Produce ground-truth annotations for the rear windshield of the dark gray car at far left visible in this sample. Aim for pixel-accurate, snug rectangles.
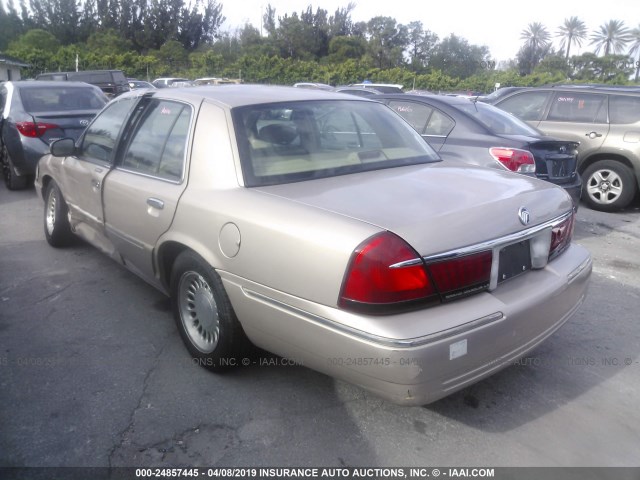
[20,86,107,112]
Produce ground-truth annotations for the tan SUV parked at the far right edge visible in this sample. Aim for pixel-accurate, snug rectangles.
[494,85,640,211]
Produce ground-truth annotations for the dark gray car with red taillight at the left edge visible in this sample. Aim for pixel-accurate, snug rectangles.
[0,81,107,190]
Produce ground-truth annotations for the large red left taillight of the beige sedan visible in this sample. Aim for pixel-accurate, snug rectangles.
[339,232,492,314]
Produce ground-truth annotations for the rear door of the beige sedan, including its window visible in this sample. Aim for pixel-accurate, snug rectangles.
[104,98,194,283]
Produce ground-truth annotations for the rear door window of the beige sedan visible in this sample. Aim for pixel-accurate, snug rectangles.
[121,100,191,181]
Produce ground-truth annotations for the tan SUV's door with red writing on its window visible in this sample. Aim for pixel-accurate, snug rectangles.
[538,91,609,158]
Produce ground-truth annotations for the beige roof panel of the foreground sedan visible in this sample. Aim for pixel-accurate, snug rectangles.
[130,85,369,108]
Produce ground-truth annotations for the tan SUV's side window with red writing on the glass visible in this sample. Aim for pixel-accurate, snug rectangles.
[547,92,607,123]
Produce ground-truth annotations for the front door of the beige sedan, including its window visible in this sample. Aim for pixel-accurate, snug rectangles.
[57,94,135,254]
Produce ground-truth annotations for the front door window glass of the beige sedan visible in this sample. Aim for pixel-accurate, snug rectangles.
[79,98,134,163]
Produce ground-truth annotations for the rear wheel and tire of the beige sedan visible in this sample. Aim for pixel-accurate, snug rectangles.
[171,251,248,371]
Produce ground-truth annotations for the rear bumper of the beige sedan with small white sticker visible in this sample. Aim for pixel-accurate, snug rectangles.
[220,244,592,405]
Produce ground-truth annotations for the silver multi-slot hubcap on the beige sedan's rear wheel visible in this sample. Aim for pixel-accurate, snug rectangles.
[178,272,220,353]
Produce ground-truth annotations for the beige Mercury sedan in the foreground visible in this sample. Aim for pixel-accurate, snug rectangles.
[36,85,591,405]
